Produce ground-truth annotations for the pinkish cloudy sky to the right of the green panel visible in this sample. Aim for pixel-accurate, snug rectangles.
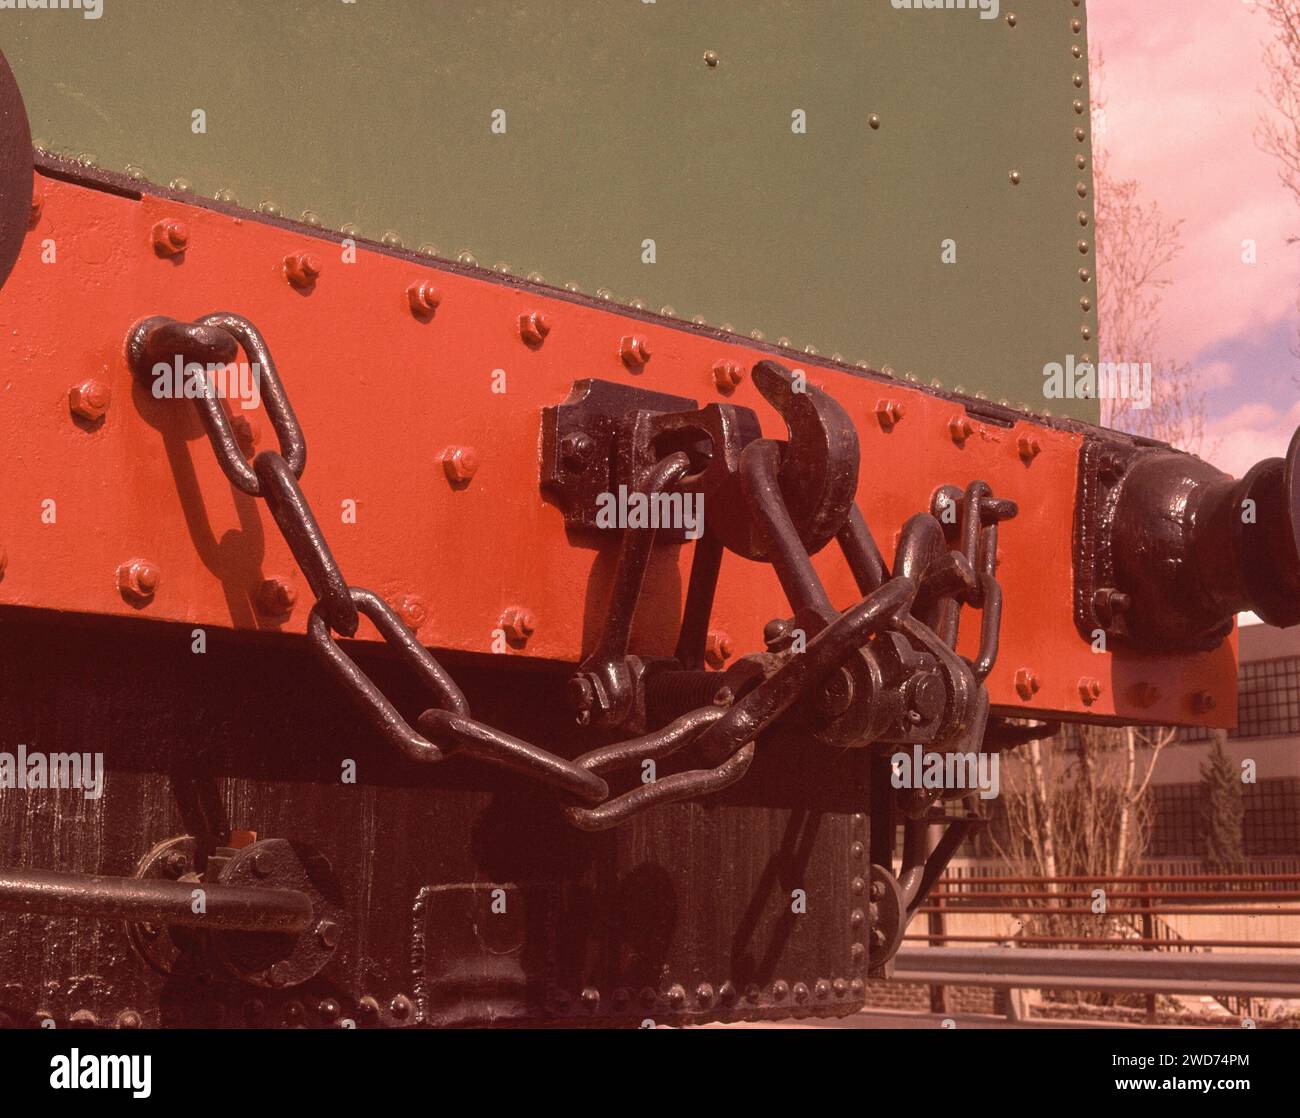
[1088,0,1300,475]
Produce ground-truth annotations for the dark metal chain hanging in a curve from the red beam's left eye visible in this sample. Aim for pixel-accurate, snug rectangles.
[129,312,761,831]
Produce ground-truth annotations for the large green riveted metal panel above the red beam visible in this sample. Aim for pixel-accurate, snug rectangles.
[0,0,1096,420]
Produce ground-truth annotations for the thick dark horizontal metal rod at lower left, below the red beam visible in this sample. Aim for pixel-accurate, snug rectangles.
[0,870,312,935]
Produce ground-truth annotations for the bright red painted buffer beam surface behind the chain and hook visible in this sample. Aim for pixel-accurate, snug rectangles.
[0,165,1236,724]
